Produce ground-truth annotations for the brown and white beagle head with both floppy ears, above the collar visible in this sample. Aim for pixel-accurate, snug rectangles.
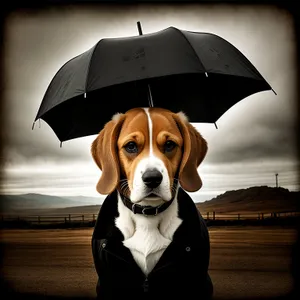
[91,108,207,203]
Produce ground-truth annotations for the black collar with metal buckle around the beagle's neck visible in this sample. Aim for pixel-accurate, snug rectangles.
[120,194,174,216]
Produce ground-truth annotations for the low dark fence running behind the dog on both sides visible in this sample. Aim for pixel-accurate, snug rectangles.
[0,211,300,225]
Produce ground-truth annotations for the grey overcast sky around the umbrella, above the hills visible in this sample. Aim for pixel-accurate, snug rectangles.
[0,4,299,200]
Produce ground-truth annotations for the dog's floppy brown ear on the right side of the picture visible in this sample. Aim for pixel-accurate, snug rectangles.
[174,112,207,192]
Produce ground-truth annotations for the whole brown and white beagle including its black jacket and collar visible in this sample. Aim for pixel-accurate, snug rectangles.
[91,107,213,299]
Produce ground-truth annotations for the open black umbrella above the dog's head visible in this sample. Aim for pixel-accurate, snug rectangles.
[35,22,272,142]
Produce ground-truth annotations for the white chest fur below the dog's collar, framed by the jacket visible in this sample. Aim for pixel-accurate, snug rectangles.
[115,198,182,275]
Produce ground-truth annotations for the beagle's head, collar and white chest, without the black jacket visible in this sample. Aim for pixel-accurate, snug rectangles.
[91,107,207,276]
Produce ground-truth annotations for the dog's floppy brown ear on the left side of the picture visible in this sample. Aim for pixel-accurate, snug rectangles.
[91,114,125,195]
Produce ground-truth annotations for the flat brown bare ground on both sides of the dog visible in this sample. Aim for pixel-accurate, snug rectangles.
[1,227,296,299]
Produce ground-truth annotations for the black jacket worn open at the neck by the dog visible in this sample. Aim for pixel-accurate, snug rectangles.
[92,189,213,300]
